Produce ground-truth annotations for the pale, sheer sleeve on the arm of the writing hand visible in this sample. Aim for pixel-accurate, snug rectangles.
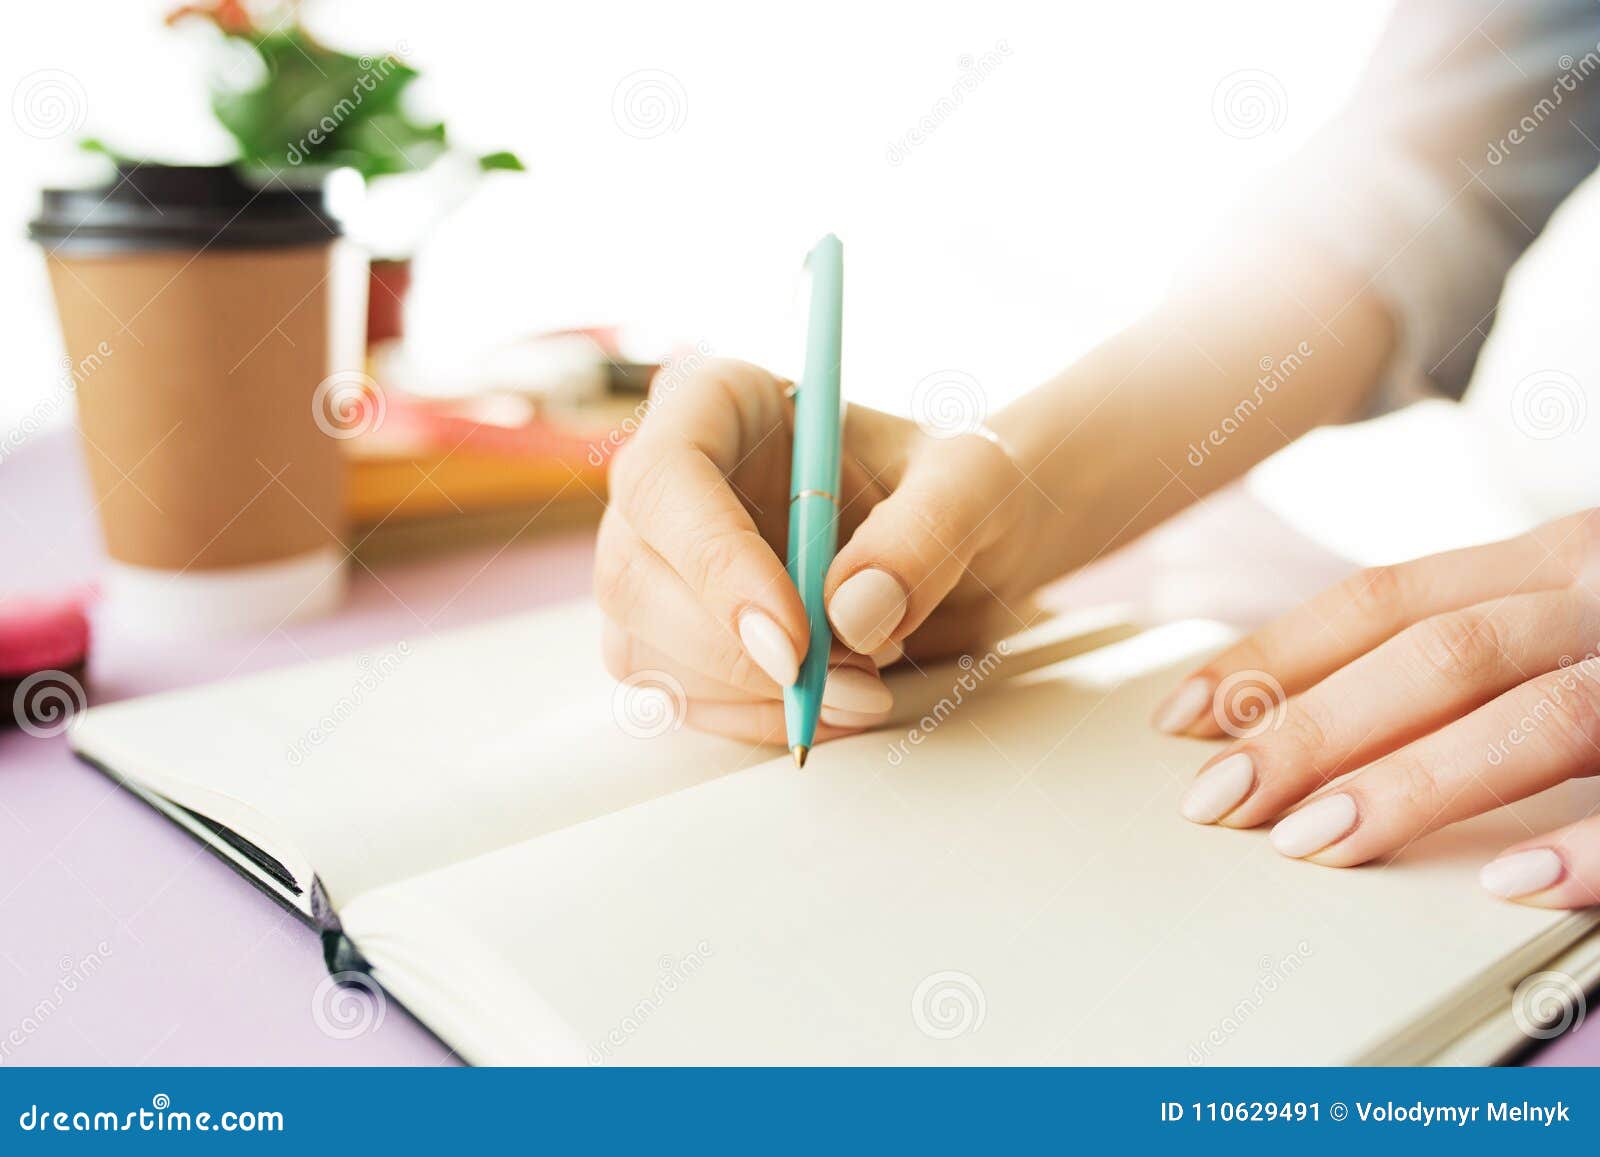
[1209,0,1600,408]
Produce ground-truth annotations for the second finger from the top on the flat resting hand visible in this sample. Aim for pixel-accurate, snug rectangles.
[1181,587,1600,827]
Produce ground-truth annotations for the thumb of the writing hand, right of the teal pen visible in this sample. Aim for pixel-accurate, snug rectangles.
[824,434,1022,653]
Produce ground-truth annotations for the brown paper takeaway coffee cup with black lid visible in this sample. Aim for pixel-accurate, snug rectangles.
[29,165,358,631]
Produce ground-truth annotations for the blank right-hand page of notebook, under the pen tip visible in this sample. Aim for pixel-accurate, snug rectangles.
[342,624,1597,1064]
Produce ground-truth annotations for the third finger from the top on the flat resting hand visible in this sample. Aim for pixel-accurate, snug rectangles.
[1270,658,1600,867]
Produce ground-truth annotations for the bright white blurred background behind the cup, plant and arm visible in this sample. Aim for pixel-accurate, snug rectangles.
[0,0,1600,560]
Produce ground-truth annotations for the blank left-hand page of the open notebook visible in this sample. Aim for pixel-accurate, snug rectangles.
[72,603,765,904]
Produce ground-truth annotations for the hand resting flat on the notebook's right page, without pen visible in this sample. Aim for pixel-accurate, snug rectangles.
[1155,510,1600,907]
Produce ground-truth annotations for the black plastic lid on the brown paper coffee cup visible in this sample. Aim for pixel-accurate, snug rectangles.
[27,163,339,253]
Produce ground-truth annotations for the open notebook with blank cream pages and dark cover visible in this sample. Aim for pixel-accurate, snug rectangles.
[72,607,1600,1064]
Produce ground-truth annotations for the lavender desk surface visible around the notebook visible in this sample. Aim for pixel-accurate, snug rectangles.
[0,434,1600,1064]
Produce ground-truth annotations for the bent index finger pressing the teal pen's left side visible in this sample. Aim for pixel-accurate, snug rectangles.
[610,362,808,685]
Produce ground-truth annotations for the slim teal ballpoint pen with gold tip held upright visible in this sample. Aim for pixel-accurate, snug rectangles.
[784,234,845,767]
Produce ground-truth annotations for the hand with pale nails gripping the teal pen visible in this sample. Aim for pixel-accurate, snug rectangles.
[595,362,1037,743]
